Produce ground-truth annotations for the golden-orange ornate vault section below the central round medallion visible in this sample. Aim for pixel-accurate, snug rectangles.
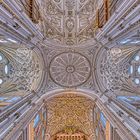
[46,93,94,136]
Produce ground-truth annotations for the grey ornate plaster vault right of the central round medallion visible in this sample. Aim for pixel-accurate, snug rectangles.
[95,46,139,95]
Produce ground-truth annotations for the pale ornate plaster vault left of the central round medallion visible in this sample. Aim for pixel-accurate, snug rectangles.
[0,38,43,96]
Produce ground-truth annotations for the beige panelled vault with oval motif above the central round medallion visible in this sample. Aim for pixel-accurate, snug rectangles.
[43,0,95,45]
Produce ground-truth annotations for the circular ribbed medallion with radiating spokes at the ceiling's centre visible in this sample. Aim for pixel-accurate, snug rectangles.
[50,52,90,87]
